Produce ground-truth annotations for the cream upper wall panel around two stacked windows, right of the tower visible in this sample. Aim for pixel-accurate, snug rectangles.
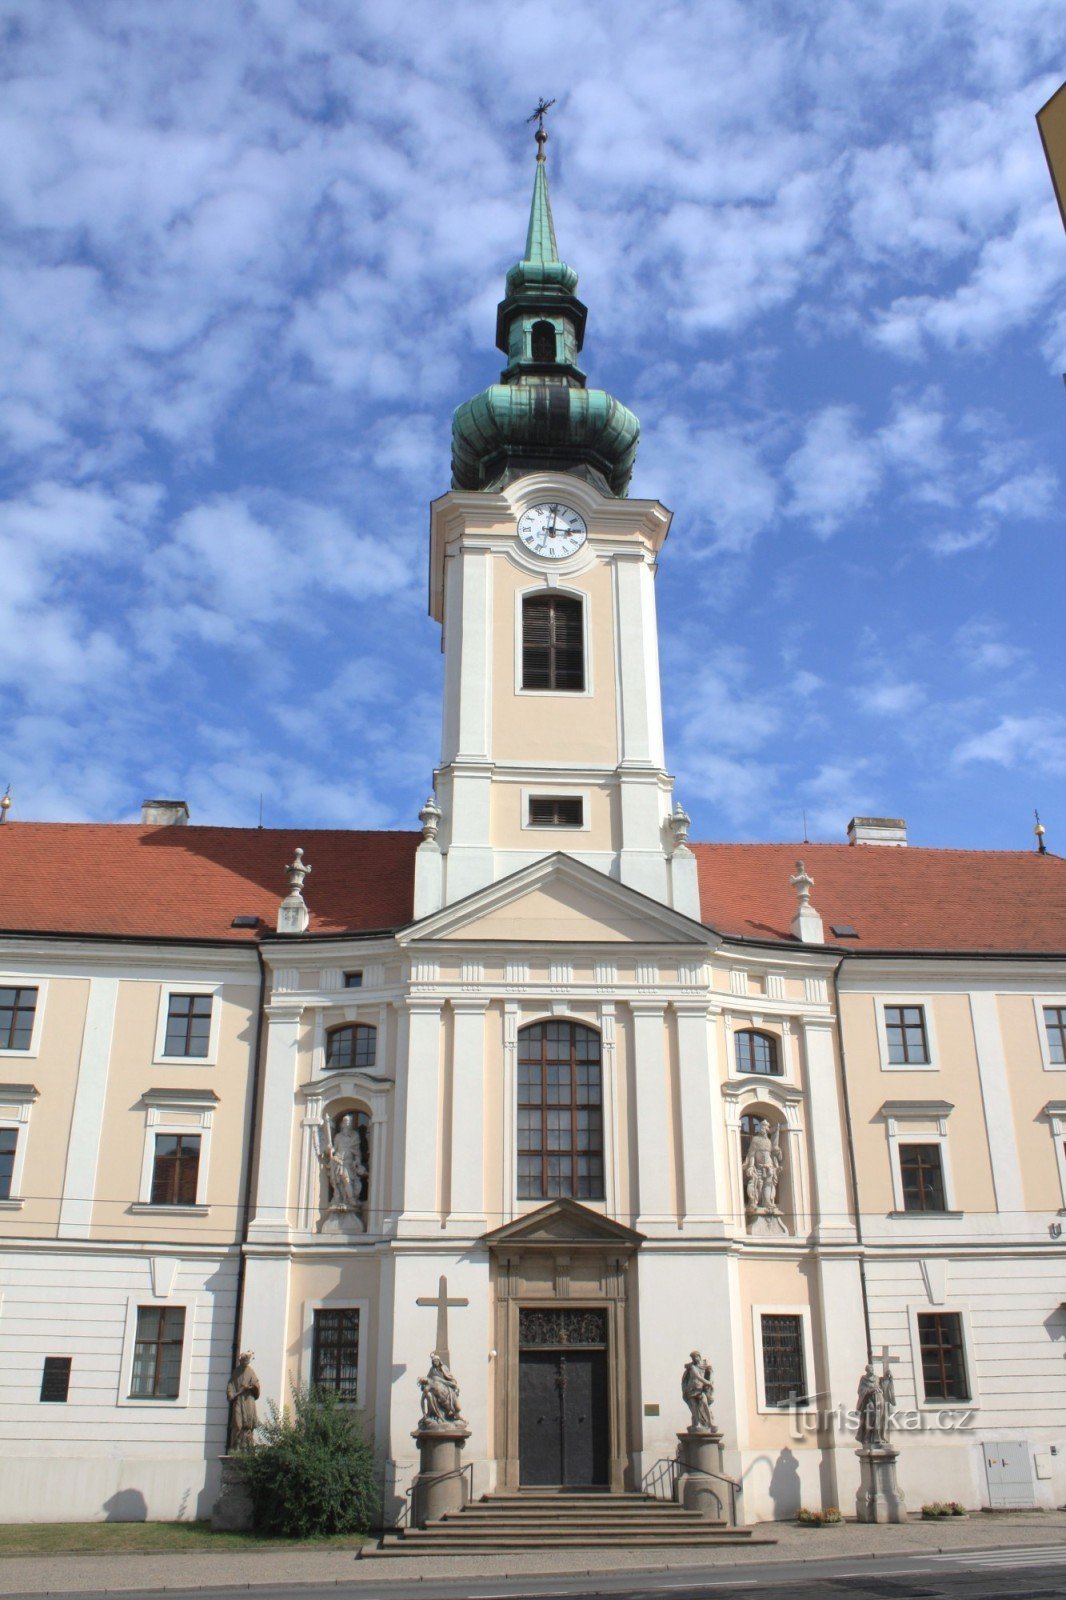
[840,990,996,1213]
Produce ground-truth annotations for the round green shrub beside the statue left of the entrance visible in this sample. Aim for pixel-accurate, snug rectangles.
[235,1384,379,1539]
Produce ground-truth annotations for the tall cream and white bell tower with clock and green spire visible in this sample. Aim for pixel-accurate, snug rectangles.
[408,117,699,936]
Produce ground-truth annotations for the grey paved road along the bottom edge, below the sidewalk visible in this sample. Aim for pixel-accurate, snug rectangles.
[14,1544,1066,1600]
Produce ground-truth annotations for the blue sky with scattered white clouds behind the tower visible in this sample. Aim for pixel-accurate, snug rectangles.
[0,0,1066,848]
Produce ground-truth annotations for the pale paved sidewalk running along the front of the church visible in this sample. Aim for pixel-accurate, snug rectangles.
[0,1510,1066,1595]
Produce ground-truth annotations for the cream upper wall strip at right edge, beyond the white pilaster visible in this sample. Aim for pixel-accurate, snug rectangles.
[997,995,1066,1213]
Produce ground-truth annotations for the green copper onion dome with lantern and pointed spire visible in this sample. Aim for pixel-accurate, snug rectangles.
[451,133,640,496]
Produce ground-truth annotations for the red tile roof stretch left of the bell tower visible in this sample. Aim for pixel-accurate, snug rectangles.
[0,822,421,944]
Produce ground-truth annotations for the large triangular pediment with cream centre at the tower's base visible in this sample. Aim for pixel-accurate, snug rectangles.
[400,854,707,946]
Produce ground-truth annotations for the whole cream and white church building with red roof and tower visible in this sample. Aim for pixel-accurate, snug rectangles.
[0,142,1066,1522]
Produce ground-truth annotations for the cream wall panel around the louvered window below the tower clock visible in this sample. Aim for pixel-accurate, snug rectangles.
[491,557,618,766]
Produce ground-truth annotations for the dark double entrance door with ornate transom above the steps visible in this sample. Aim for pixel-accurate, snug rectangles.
[519,1310,610,1488]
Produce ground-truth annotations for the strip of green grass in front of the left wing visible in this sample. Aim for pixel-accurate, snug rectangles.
[0,1522,365,1555]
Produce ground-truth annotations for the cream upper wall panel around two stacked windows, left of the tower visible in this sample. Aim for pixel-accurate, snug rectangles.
[93,981,258,1245]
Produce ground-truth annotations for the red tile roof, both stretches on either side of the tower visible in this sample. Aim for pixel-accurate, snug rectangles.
[0,822,1066,954]
